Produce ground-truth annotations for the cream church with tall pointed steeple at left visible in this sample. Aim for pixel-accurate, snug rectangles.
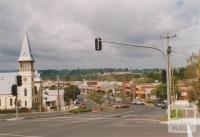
[0,34,43,109]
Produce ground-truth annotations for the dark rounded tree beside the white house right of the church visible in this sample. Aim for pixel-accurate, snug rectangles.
[64,85,81,103]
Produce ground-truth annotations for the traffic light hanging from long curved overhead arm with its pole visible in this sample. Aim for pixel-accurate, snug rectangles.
[95,36,171,120]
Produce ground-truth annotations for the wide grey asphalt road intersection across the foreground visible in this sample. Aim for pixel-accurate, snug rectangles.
[0,106,200,137]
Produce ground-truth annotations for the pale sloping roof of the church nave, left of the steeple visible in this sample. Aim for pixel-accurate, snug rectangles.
[0,72,18,95]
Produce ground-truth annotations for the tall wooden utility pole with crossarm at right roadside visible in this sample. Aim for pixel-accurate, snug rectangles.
[160,32,176,120]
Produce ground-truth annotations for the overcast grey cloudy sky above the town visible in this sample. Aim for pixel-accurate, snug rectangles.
[0,0,200,70]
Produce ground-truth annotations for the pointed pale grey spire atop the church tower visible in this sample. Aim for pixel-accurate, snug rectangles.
[18,33,34,61]
